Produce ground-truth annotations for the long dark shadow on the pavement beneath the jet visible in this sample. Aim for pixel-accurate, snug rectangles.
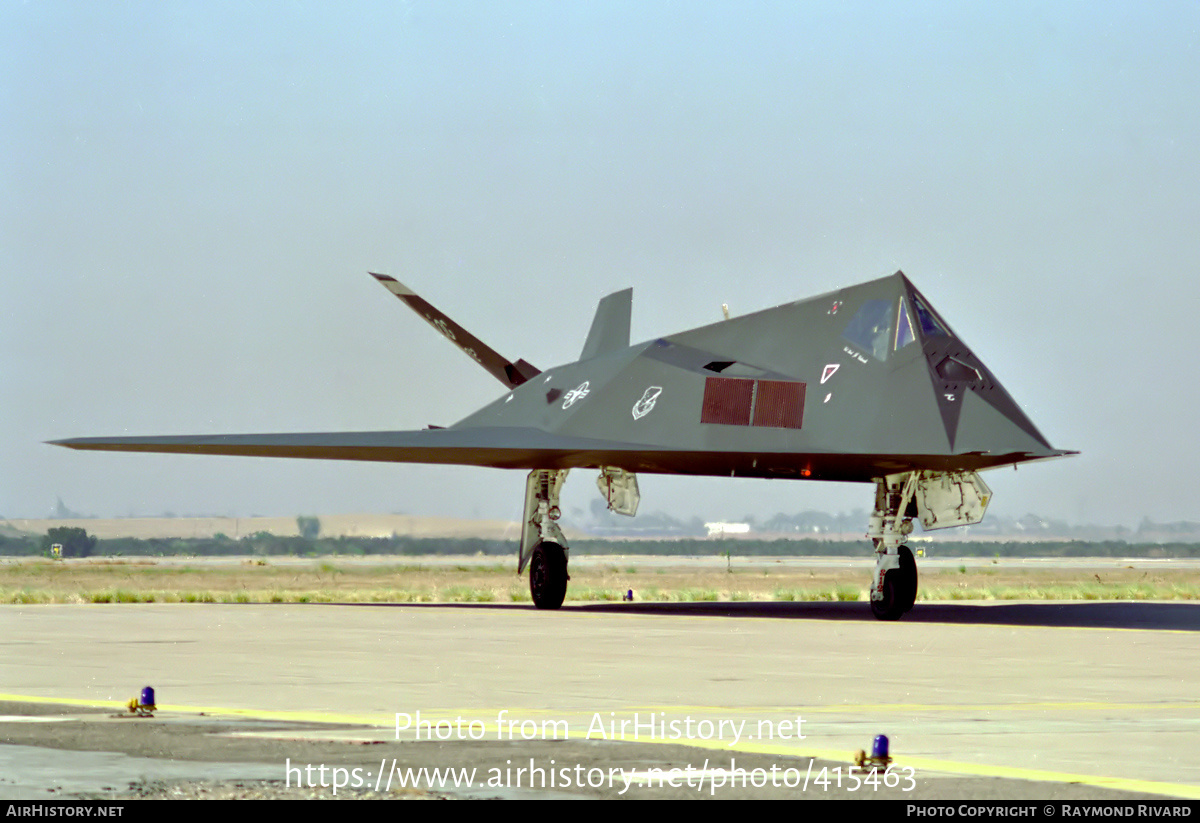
[340,601,1200,631]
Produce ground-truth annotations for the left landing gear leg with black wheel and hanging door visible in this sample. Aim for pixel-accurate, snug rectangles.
[517,465,641,608]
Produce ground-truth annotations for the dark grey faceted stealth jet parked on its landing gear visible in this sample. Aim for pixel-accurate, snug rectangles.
[54,271,1075,620]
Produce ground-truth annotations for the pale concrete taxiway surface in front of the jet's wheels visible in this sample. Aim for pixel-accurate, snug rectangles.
[0,602,1200,799]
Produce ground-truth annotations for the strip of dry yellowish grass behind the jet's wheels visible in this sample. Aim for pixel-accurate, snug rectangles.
[0,558,1200,603]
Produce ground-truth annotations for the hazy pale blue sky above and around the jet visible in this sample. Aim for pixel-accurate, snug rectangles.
[0,0,1200,524]
